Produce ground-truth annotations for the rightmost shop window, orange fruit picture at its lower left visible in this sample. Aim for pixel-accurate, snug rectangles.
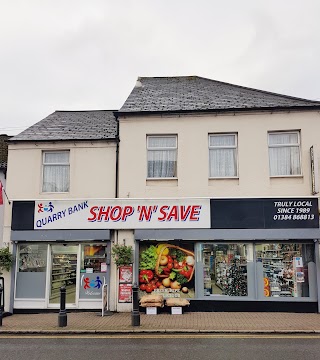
[256,243,314,297]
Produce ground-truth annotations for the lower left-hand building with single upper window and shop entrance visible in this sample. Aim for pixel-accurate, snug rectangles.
[4,111,118,311]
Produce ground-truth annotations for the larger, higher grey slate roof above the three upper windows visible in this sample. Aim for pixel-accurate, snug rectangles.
[119,76,320,114]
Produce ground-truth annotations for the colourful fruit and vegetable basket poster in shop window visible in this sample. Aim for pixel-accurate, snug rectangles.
[139,242,195,298]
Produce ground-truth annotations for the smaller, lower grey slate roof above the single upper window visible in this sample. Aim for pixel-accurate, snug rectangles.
[10,110,117,141]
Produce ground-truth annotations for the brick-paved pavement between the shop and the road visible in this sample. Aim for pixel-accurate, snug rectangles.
[0,312,320,335]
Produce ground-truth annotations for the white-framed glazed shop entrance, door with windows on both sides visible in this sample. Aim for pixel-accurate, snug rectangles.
[15,242,110,307]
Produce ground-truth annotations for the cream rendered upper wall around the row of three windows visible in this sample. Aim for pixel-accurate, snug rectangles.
[119,111,320,198]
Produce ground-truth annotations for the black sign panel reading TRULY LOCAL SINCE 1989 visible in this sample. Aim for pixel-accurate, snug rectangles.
[210,198,319,229]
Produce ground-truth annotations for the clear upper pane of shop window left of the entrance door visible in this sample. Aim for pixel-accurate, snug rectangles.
[18,244,47,272]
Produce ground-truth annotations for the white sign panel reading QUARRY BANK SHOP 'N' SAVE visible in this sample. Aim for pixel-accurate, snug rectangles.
[34,198,210,230]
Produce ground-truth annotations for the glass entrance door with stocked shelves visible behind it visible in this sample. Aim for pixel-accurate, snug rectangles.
[49,245,78,304]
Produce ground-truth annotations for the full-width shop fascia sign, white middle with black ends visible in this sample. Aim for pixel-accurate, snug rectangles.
[11,197,319,230]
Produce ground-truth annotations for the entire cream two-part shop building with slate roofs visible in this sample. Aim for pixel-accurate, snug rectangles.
[5,77,320,312]
